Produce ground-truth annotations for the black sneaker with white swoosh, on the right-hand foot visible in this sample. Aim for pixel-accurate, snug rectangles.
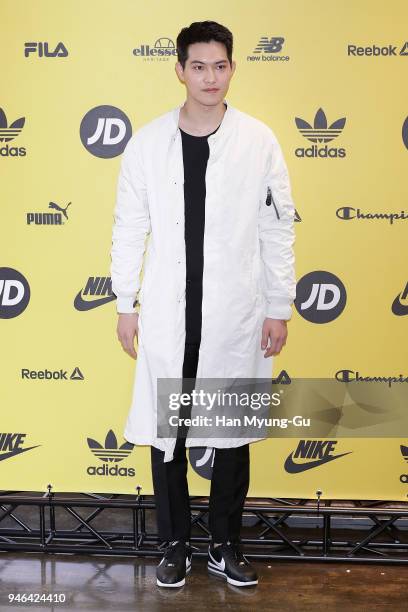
[208,542,258,586]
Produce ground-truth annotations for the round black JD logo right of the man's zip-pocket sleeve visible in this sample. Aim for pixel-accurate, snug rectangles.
[295,270,347,323]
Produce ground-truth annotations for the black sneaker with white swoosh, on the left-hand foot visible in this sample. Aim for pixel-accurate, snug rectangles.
[156,540,191,587]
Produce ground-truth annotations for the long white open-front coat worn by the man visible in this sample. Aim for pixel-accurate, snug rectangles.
[111,101,296,461]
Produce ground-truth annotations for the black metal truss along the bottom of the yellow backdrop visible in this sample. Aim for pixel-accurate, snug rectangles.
[0,485,408,564]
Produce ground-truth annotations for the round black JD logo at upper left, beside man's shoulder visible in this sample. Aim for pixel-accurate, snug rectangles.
[79,106,132,159]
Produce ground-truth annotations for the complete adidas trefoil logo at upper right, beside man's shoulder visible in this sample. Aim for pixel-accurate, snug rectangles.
[295,108,346,158]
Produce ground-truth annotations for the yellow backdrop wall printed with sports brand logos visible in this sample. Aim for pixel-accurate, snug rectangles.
[0,0,408,499]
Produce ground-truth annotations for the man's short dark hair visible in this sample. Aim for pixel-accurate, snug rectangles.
[176,21,233,69]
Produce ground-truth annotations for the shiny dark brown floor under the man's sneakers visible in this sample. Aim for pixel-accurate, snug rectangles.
[0,552,408,612]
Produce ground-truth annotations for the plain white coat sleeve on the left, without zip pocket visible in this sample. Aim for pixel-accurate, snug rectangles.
[110,135,151,313]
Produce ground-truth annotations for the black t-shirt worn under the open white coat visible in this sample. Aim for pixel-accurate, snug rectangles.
[180,126,219,343]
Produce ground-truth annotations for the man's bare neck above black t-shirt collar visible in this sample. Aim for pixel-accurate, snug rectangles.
[179,98,226,136]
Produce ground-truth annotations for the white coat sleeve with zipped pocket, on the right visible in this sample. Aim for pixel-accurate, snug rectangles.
[258,130,296,321]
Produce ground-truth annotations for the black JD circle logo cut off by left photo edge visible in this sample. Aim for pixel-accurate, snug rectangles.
[0,268,30,319]
